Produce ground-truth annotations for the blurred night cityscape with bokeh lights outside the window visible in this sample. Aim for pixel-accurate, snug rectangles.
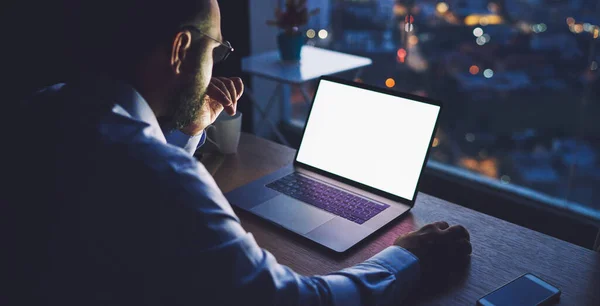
[292,0,600,218]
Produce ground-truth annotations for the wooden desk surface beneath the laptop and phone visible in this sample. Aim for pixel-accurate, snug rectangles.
[205,134,600,306]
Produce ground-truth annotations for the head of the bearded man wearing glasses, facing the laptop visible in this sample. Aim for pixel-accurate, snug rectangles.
[70,0,227,127]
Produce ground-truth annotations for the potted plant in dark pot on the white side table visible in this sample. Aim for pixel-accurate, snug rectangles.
[267,0,319,61]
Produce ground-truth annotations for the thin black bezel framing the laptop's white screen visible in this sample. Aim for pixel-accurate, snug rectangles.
[294,76,443,207]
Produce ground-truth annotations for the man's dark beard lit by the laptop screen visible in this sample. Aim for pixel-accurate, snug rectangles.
[169,74,206,129]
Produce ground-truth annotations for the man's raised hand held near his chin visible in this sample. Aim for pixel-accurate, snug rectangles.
[181,77,244,136]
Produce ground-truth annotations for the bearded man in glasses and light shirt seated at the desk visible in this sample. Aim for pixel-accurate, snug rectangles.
[3,0,471,306]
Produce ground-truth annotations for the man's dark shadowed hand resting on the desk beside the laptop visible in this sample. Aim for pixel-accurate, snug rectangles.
[394,221,472,280]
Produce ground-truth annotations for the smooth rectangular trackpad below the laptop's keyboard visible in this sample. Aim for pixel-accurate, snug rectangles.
[250,195,335,234]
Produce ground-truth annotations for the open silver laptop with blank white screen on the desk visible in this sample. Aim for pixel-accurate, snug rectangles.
[225,76,441,252]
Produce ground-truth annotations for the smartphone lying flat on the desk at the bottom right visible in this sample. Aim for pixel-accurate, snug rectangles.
[477,273,560,306]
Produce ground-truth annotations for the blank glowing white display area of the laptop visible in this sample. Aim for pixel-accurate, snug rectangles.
[297,80,440,200]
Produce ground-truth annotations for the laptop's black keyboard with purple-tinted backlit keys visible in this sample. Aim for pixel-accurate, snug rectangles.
[267,173,390,224]
